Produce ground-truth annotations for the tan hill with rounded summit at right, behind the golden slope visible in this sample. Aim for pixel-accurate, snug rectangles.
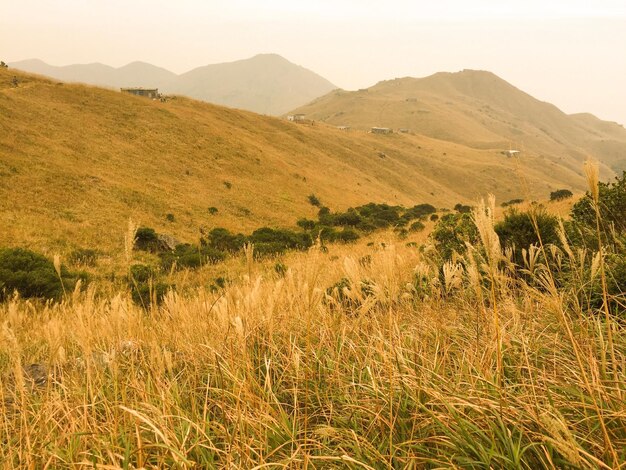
[294,70,626,177]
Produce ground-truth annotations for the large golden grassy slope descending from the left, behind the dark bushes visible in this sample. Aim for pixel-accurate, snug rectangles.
[0,69,585,251]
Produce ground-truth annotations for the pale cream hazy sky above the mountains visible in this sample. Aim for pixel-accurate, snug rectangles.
[0,0,626,124]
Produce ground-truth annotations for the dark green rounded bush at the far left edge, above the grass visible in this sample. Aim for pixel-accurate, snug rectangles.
[0,248,78,300]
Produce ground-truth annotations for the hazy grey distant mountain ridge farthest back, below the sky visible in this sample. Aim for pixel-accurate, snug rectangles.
[9,54,336,115]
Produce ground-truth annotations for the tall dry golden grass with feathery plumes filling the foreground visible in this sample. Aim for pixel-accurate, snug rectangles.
[0,218,626,469]
